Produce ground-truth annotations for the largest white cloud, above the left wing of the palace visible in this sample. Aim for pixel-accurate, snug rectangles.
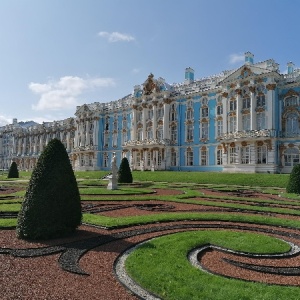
[28,76,115,111]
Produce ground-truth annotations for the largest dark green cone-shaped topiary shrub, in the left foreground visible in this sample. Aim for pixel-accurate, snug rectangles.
[17,139,82,239]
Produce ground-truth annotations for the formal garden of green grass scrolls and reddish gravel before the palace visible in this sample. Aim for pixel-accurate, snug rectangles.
[0,146,300,300]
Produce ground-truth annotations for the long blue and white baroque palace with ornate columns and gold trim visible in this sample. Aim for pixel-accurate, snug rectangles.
[0,52,300,173]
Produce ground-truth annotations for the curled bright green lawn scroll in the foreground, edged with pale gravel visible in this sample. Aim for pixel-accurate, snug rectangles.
[126,230,299,300]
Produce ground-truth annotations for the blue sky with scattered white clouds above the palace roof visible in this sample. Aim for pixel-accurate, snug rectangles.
[0,0,300,126]
